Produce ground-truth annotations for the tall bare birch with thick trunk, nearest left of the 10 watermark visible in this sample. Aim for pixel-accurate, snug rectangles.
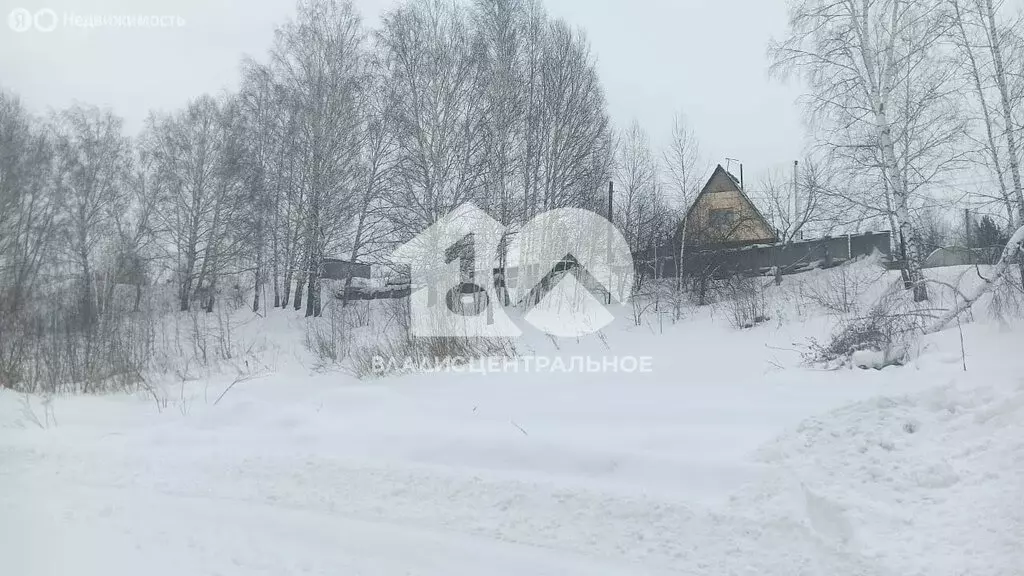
[271,0,367,317]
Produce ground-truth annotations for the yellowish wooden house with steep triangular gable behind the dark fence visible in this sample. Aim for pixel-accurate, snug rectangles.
[685,164,778,252]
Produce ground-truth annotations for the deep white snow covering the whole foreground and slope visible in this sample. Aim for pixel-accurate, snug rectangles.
[0,262,1024,576]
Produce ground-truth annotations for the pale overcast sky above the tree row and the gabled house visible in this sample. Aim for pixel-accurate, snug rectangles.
[0,0,803,181]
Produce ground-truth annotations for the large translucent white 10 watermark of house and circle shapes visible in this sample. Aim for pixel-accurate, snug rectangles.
[391,203,634,337]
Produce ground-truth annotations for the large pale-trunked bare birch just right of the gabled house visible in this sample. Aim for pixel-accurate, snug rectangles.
[769,0,951,300]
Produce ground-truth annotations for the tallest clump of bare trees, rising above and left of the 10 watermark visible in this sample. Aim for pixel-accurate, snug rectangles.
[235,0,611,316]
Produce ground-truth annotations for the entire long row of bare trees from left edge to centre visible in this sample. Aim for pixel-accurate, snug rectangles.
[0,0,613,386]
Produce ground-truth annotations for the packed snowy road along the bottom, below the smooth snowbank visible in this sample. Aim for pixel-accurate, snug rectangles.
[3,428,876,574]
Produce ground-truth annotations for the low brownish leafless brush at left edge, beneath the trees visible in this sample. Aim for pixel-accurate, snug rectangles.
[0,276,276,394]
